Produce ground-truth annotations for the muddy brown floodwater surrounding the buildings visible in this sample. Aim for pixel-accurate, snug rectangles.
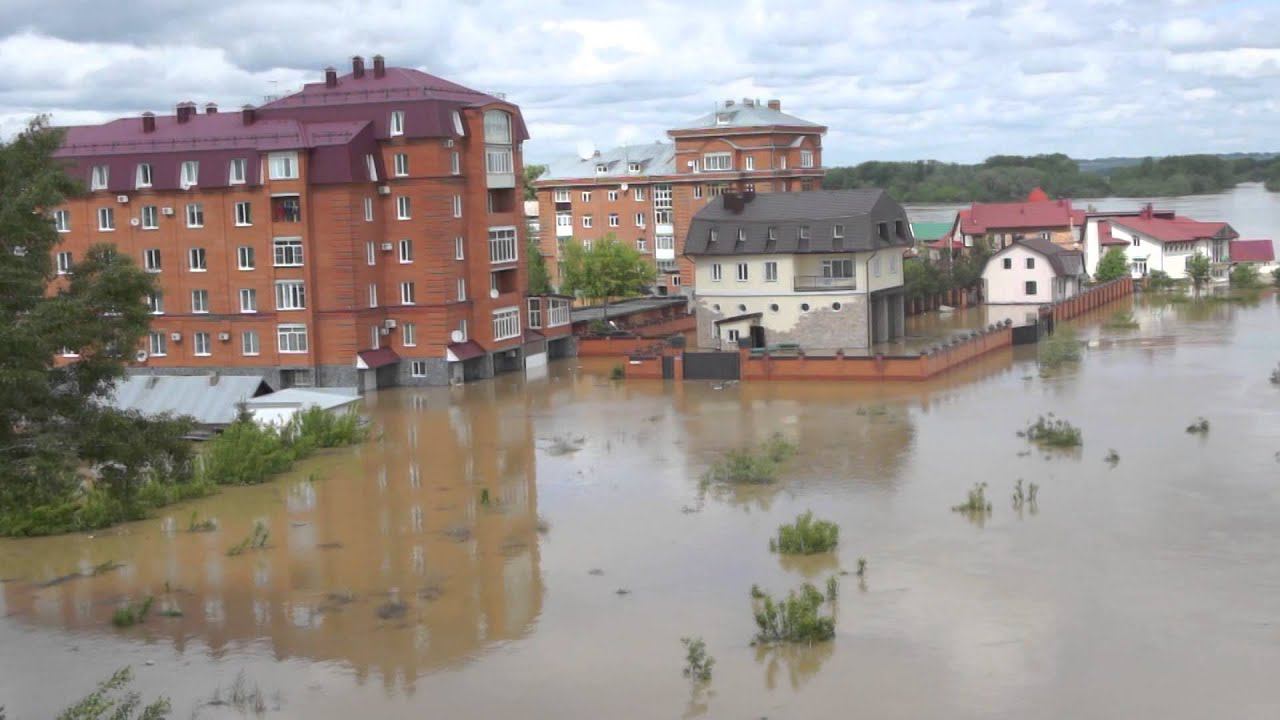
[0,288,1280,720]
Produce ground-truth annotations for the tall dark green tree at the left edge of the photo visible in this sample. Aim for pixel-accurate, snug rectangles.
[0,118,191,534]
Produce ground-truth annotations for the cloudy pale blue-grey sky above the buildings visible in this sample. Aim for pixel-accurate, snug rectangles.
[0,0,1280,165]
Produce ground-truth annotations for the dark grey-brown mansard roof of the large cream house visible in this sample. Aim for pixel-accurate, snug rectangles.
[685,188,911,255]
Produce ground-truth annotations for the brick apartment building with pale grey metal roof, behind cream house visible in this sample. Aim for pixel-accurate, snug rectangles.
[534,99,827,295]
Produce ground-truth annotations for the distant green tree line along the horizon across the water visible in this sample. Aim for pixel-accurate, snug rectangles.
[823,152,1280,202]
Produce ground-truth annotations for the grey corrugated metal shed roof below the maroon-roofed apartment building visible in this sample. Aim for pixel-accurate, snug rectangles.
[105,375,271,425]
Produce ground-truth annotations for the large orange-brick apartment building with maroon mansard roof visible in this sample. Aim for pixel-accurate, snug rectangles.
[54,56,571,388]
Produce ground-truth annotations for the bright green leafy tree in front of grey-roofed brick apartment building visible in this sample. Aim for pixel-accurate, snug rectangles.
[561,233,657,318]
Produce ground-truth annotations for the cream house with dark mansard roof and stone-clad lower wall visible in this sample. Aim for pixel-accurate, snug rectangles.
[685,190,914,351]
